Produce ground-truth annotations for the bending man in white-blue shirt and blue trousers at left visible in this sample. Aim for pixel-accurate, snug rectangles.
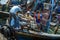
[9,6,22,27]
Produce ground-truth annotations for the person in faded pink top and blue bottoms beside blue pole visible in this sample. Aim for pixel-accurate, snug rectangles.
[42,8,50,33]
